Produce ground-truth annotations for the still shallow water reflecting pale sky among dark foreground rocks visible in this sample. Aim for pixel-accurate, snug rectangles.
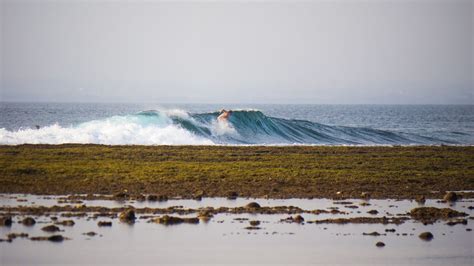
[0,194,474,265]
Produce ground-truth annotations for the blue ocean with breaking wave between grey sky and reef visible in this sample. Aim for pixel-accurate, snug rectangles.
[0,102,474,145]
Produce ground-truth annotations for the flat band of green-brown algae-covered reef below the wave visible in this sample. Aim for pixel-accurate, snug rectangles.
[0,144,474,198]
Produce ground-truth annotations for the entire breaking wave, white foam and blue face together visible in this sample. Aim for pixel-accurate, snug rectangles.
[0,110,458,145]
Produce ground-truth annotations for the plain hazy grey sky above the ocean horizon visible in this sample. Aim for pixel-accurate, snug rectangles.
[0,0,474,104]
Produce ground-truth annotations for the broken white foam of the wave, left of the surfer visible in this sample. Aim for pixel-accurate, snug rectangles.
[0,117,214,145]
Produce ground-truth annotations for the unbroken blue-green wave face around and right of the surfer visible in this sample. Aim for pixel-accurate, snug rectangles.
[171,110,455,145]
